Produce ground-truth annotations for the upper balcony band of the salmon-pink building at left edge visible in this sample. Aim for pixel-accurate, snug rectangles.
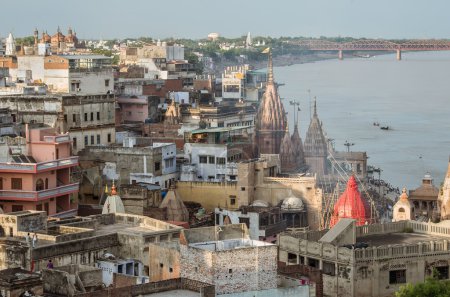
[0,157,78,173]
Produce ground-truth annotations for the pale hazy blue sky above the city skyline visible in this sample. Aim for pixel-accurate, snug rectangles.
[0,0,450,39]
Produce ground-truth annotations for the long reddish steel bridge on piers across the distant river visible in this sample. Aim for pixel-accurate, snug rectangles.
[295,39,450,60]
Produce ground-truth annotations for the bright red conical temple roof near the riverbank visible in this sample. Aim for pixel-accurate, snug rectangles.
[330,175,370,228]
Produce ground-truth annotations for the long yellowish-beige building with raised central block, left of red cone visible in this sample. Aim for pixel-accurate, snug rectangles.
[177,155,322,229]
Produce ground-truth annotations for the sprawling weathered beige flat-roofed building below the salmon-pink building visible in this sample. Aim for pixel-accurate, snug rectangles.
[0,211,182,275]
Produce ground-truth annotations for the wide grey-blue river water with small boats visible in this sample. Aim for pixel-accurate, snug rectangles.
[274,52,450,189]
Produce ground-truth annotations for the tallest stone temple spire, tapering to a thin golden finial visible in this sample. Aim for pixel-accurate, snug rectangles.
[255,51,287,155]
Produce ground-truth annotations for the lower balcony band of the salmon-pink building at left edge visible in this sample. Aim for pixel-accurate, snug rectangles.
[0,183,79,201]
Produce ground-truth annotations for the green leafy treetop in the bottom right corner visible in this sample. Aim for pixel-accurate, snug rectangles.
[395,270,450,297]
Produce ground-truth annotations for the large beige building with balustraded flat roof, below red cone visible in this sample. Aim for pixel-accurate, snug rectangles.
[279,219,450,297]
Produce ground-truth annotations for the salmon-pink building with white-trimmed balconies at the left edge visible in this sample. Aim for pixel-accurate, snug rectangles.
[0,123,79,217]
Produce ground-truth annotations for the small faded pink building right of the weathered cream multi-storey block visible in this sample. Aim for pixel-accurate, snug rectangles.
[117,98,148,123]
